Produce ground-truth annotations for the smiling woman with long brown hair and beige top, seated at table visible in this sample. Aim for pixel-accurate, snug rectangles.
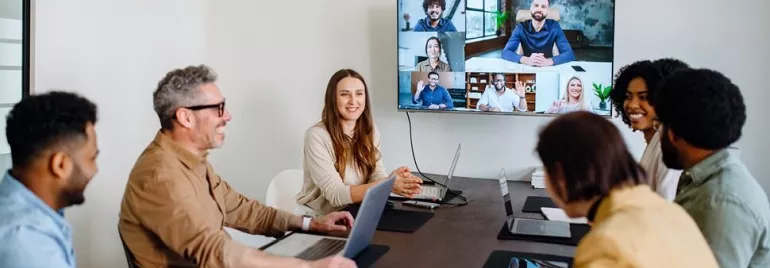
[297,69,422,214]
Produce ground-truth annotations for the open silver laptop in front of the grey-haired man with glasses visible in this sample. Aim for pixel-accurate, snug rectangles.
[263,176,395,260]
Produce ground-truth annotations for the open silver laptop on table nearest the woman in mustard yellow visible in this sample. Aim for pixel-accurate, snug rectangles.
[498,169,572,238]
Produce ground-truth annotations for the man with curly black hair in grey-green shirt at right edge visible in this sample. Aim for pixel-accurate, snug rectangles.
[655,69,770,267]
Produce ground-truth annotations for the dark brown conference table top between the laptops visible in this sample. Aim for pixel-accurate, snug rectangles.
[371,174,575,267]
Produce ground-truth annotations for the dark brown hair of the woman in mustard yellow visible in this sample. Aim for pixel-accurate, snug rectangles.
[535,111,647,202]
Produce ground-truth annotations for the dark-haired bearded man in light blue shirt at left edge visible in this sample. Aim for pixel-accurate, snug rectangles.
[0,92,98,268]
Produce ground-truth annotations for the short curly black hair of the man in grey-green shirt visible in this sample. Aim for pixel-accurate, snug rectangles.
[654,69,746,150]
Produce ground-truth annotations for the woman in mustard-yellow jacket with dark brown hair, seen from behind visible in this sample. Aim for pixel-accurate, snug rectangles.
[536,111,718,267]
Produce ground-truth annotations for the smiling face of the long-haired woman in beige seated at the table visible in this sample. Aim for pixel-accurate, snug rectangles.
[336,77,366,121]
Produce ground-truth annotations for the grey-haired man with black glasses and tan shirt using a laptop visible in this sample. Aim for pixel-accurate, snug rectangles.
[118,65,355,267]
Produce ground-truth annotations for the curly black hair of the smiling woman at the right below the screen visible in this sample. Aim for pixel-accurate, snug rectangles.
[610,58,690,127]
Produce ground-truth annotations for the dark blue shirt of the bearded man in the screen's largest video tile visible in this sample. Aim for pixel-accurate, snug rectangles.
[503,19,575,65]
